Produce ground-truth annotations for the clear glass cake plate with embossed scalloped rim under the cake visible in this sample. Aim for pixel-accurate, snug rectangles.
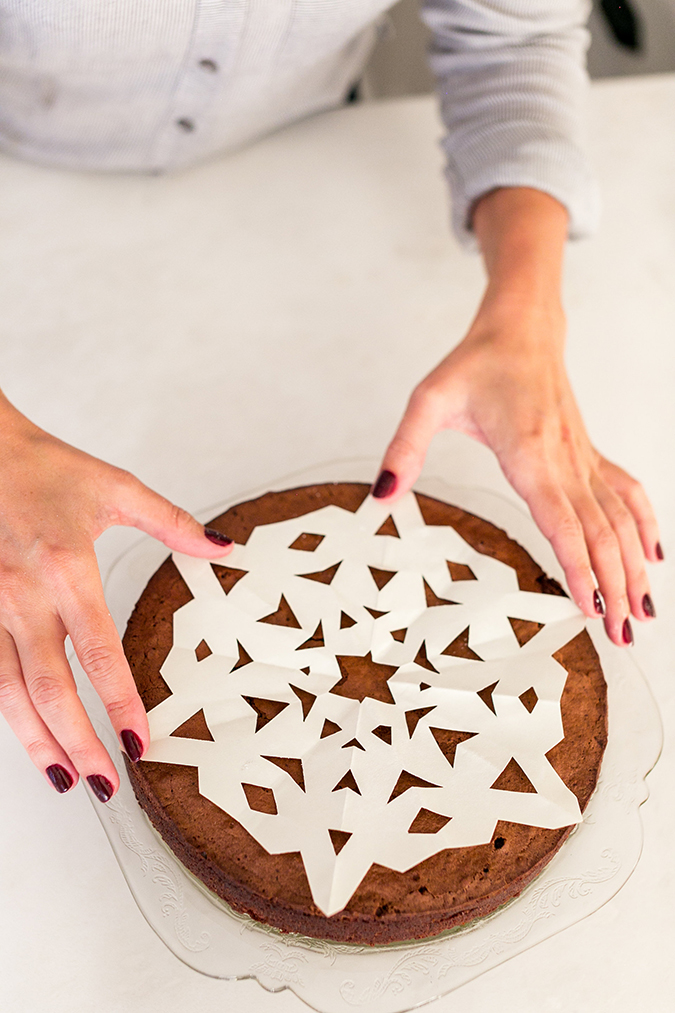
[70,460,662,1013]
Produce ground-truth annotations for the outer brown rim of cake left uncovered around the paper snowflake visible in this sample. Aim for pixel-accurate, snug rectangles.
[124,483,607,945]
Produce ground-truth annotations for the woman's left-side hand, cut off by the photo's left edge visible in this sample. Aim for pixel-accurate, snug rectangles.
[0,394,231,802]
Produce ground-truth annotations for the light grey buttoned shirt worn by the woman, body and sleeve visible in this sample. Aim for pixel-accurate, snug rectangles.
[0,0,597,242]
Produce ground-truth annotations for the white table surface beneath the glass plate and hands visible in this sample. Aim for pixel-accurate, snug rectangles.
[0,76,675,1013]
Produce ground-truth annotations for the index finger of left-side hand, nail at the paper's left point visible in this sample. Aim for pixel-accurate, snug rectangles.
[58,557,150,763]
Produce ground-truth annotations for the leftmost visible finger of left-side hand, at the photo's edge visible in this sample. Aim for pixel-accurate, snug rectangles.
[0,627,78,794]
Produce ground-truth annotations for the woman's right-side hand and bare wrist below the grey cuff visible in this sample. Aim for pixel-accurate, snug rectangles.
[374,190,663,644]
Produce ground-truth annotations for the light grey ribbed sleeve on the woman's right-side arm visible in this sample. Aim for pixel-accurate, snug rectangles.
[423,0,599,248]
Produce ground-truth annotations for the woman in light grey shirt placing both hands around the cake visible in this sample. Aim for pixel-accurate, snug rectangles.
[0,0,663,802]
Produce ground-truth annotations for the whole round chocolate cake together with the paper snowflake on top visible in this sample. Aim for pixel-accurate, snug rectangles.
[124,483,607,945]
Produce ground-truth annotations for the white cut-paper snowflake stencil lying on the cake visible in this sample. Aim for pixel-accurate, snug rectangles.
[146,493,584,916]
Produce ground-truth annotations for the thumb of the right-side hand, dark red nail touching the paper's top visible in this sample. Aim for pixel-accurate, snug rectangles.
[373,384,445,502]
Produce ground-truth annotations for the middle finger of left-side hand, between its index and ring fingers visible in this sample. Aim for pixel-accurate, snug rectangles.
[10,613,120,801]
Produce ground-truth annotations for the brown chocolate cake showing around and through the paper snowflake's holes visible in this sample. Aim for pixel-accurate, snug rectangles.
[124,483,607,944]
